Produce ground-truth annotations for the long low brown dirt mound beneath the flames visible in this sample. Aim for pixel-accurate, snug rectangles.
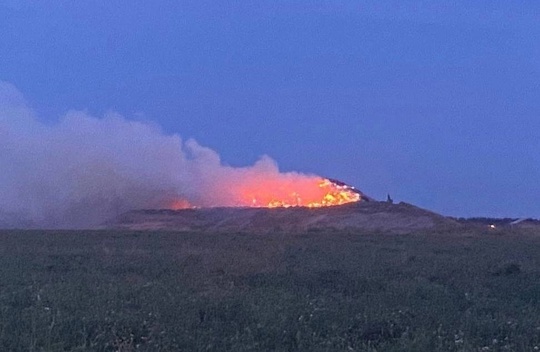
[112,202,457,233]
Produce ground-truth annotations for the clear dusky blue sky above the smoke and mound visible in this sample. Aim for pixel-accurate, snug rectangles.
[0,0,540,218]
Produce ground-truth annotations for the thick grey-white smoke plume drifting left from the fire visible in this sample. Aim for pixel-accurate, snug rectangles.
[0,82,311,228]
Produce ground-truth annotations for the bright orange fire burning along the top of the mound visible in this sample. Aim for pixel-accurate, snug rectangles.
[170,177,367,210]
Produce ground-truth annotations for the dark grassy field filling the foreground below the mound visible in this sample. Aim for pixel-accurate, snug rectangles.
[0,227,540,351]
